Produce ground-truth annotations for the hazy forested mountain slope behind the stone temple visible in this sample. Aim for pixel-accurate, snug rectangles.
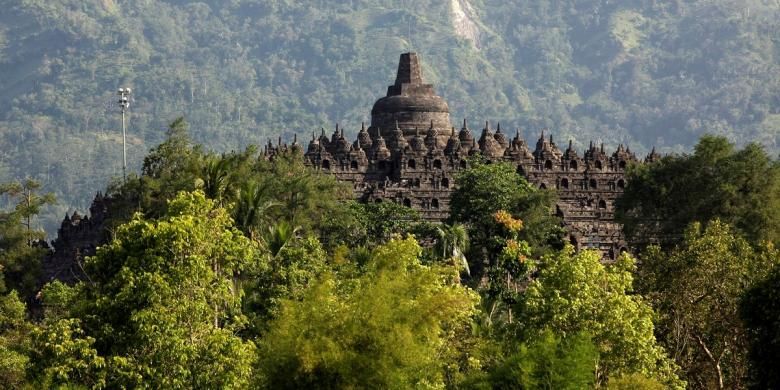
[0,0,780,232]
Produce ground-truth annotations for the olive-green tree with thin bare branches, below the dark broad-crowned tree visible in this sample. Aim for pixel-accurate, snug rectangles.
[636,220,778,388]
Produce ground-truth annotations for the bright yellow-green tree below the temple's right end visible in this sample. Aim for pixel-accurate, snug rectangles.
[517,245,684,388]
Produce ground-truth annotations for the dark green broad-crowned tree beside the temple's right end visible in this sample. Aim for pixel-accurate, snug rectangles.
[616,136,780,246]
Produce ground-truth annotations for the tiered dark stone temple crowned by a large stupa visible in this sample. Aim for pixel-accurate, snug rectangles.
[292,53,657,258]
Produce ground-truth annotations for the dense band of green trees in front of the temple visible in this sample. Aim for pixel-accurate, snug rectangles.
[0,119,780,389]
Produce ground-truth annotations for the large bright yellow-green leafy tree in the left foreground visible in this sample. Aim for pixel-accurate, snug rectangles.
[38,191,260,388]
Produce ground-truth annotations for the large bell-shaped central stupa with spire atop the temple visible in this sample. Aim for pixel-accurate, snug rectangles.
[369,53,452,138]
